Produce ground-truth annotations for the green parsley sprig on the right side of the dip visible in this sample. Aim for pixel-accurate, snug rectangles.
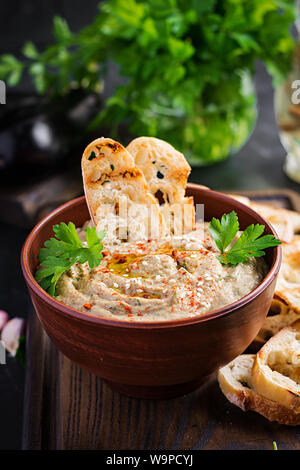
[209,211,281,265]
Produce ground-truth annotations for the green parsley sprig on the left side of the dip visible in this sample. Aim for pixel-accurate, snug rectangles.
[35,222,105,297]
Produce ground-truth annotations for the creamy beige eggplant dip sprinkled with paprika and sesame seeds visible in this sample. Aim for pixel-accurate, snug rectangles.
[57,222,267,322]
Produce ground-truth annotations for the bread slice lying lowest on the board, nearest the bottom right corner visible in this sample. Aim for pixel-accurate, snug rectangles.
[218,354,300,426]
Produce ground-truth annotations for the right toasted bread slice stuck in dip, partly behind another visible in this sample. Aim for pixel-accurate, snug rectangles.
[127,137,195,235]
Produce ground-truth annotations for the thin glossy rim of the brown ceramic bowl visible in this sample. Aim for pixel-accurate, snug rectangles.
[21,183,282,329]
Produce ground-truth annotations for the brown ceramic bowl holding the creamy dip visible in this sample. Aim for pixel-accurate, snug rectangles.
[22,184,281,398]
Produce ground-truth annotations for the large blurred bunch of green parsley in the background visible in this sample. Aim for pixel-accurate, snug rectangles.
[0,0,295,163]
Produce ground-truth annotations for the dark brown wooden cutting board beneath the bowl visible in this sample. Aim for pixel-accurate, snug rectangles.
[23,190,300,450]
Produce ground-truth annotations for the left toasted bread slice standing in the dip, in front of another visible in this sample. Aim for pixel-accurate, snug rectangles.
[82,137,165,242]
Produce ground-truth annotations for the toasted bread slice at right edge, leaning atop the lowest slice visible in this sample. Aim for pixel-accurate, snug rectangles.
[252,320,300,413]
